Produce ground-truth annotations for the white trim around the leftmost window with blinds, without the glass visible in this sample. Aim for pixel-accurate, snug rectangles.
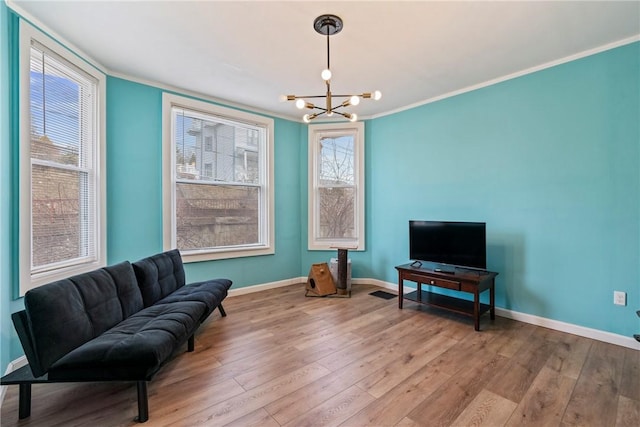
[18,20,107,296]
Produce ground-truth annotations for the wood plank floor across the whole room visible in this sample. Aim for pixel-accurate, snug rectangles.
[1,285,640,427]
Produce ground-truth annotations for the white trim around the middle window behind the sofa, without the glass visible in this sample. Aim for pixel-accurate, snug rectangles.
[162,92,275,263]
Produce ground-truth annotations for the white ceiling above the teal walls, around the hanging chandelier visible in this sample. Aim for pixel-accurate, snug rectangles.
[7,0,640,120]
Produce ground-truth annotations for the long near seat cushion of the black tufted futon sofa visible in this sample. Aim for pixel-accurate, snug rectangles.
[49,301,206,381]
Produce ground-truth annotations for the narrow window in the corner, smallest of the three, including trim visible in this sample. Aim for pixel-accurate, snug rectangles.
[309,122,364,250]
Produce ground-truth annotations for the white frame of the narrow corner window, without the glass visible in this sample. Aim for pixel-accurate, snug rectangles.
[308,122,365,251]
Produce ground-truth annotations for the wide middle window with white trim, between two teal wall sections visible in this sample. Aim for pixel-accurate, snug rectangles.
[163,94,274,262]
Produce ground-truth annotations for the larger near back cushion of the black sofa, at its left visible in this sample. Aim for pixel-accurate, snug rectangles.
[24,261,143,376]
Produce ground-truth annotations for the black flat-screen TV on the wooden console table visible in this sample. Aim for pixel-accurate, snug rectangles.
[409,220,487,269]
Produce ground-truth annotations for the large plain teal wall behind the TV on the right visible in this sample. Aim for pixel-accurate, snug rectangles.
[367,43,640,336]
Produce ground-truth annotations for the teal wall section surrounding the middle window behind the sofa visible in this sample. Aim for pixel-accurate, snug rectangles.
[107,77,303,288]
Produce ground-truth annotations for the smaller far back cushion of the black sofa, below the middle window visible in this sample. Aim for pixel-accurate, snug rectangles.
[133,249,185,307]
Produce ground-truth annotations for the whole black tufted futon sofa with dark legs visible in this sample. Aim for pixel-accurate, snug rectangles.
[1,250,231,422]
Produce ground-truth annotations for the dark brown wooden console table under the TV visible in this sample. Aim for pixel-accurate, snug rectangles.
[396,264,498,331]
